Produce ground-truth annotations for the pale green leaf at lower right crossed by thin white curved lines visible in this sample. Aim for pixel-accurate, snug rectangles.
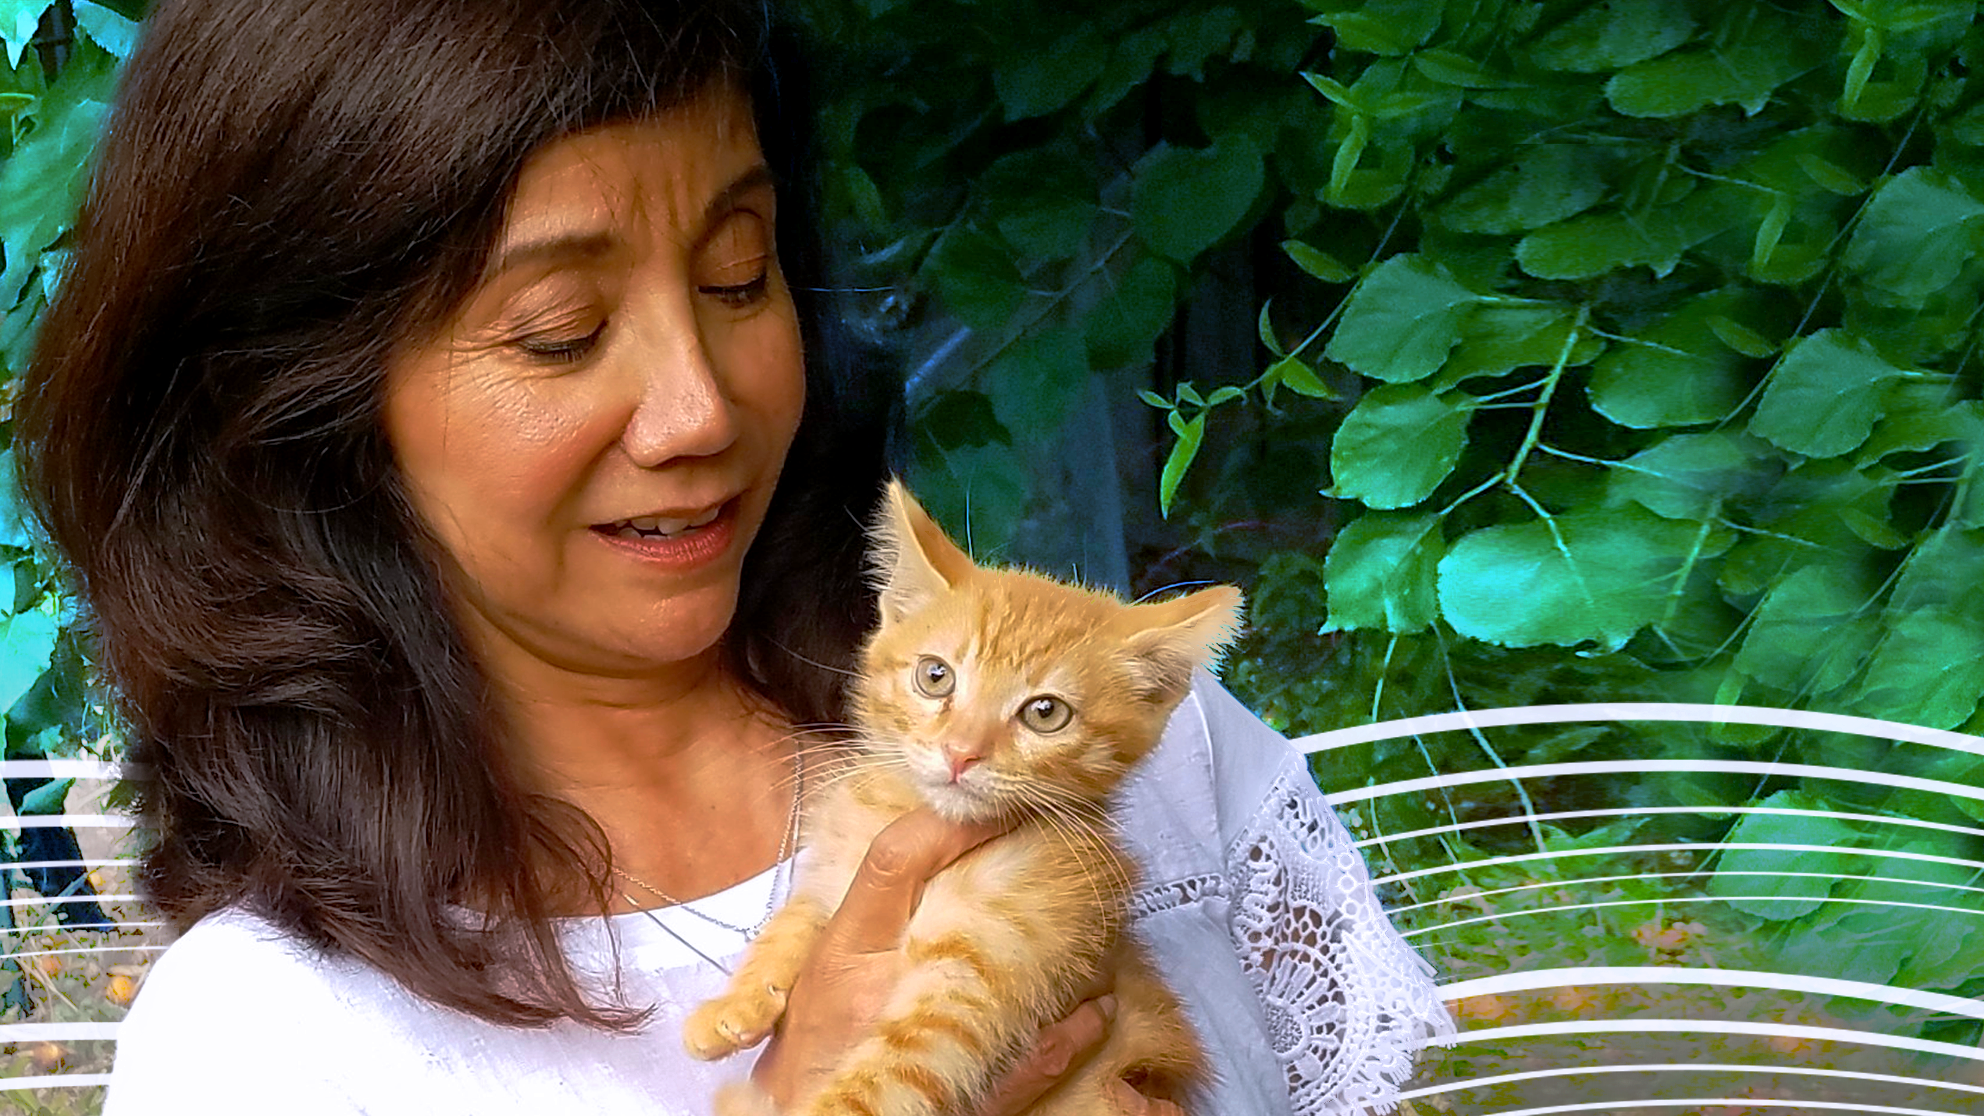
[1708,790,1867,921]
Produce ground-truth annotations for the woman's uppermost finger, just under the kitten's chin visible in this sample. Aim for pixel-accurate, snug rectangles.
[827,810,1010,953]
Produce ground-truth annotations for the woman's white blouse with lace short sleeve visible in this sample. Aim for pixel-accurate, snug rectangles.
[103,677,1450,1116]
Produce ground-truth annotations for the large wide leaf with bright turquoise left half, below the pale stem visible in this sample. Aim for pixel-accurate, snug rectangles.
[1440,508,1698,651]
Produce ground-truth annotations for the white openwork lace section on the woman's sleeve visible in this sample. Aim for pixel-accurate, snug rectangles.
[1226,772,1452,1116]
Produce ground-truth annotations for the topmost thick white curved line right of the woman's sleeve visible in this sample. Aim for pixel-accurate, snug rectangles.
[1294,701,1984,757]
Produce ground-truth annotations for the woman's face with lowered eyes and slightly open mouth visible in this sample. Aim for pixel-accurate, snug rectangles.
[385,95,804,681]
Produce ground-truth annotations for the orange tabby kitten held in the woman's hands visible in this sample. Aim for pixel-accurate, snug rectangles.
[684,483,1240,1116]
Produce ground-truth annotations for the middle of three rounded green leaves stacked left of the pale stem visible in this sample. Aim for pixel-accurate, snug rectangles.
[1329,383,1470,510]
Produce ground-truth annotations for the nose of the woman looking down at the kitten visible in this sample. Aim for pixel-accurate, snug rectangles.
[621,317,738,469]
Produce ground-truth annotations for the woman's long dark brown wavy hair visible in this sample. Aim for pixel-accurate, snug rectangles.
[16,0,887,1027]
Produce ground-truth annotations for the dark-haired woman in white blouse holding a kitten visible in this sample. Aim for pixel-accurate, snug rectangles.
[18,0,1442,1116]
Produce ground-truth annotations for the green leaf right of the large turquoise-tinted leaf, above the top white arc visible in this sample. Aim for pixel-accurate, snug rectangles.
[1736,566,1877,697]
